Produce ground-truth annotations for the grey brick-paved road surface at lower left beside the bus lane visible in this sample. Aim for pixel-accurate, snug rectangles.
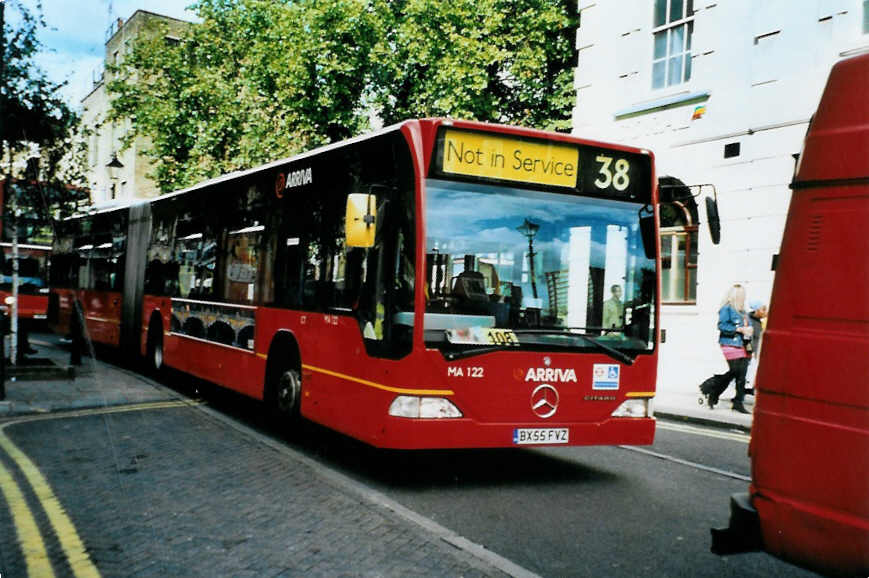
[0,405,516,577]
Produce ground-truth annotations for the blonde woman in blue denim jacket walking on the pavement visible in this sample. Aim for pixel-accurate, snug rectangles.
[710,284,753,413]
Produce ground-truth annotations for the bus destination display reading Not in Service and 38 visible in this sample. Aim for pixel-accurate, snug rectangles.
[432,128,651,203]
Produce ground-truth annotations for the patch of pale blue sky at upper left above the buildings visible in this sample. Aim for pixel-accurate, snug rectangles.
[14,0,196,110]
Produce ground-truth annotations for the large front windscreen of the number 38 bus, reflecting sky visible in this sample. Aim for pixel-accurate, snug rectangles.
[425,179,655,353]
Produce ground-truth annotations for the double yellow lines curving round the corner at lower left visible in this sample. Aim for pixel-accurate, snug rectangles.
[0,400,197,578]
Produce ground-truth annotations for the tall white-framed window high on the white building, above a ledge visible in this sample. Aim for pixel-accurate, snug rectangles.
[652,0,694,88]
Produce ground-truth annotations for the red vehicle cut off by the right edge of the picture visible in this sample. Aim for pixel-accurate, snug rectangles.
[712,55,869,576]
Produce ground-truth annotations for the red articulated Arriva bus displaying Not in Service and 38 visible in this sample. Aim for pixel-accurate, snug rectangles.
[52,119,659,449]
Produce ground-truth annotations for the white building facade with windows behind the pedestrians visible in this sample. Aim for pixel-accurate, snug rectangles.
[574,0,869,394]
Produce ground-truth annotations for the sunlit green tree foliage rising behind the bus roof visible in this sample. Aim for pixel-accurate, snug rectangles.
[108,0,576,191]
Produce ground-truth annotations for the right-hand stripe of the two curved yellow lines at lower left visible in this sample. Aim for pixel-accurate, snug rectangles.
[0,431,100,577]
